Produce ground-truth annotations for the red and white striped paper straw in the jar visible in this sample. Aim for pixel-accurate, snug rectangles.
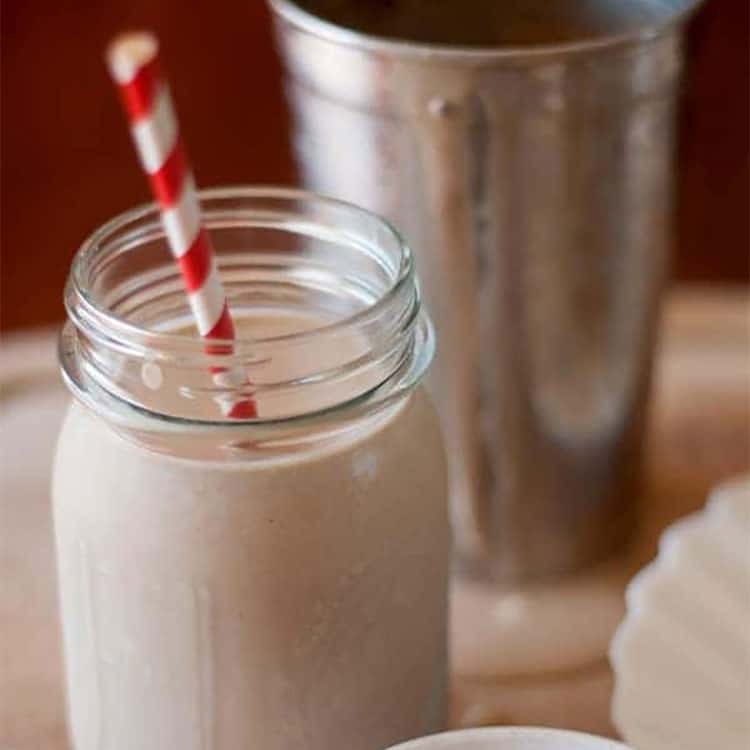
[107,32,257,419]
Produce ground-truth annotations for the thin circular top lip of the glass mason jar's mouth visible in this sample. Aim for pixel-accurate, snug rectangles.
[70,185,415,350]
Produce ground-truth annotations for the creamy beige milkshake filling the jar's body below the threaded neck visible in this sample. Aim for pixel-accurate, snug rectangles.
[53,393,447,750]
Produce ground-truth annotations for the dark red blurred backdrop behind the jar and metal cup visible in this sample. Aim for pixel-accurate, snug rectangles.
[0,0,750,331]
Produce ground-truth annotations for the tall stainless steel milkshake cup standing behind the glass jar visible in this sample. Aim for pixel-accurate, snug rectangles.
[270,0,696,583]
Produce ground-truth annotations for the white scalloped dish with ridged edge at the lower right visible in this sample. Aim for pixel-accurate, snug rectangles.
[610,477,750,750]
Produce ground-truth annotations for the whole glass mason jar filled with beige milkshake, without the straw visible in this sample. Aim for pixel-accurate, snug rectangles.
[53,188,449,750]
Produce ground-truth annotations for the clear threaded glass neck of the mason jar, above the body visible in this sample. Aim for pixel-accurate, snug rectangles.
[60,186,434,425]
